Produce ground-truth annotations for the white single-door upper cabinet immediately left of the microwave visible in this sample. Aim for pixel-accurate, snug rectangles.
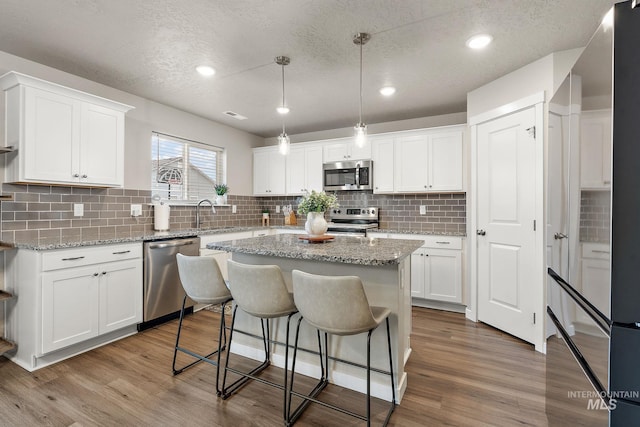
[286,144,322,195]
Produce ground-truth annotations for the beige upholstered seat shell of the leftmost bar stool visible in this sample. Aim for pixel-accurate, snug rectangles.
[176,254,231,304]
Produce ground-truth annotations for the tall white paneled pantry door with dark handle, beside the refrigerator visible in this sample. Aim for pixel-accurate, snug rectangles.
[477,107,541,342]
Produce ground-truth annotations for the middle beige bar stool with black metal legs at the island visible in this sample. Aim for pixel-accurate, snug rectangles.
[221,260,320,423]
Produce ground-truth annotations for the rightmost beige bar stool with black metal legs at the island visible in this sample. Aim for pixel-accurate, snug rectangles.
[288,270,396,426]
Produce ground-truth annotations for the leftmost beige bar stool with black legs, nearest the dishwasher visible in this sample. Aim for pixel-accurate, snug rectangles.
[173,254,233,393]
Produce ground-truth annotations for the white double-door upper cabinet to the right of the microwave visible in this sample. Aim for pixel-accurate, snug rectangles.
[392,127,464,193]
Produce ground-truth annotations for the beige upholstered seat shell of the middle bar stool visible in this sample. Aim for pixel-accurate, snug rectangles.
[227,260,297,318]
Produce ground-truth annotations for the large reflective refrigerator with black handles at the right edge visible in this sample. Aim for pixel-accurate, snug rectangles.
[546,1,640,427]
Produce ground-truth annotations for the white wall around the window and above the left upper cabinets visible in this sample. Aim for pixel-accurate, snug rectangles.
[0,51,263,195]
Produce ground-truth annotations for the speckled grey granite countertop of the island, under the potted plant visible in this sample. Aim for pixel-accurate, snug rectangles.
[207,234,424,266]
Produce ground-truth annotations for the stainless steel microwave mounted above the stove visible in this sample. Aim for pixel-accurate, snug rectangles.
[322,160,373,191]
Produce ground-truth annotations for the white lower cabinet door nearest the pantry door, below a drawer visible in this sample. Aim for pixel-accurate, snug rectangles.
[424,249,462,303]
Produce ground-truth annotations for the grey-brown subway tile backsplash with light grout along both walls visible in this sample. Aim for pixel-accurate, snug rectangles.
[0,184,466,242]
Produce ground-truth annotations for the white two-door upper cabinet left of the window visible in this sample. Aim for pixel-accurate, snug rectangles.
[0,72,132,187]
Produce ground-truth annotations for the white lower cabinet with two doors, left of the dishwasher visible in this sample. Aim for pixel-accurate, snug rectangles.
[6,243,142,371]
